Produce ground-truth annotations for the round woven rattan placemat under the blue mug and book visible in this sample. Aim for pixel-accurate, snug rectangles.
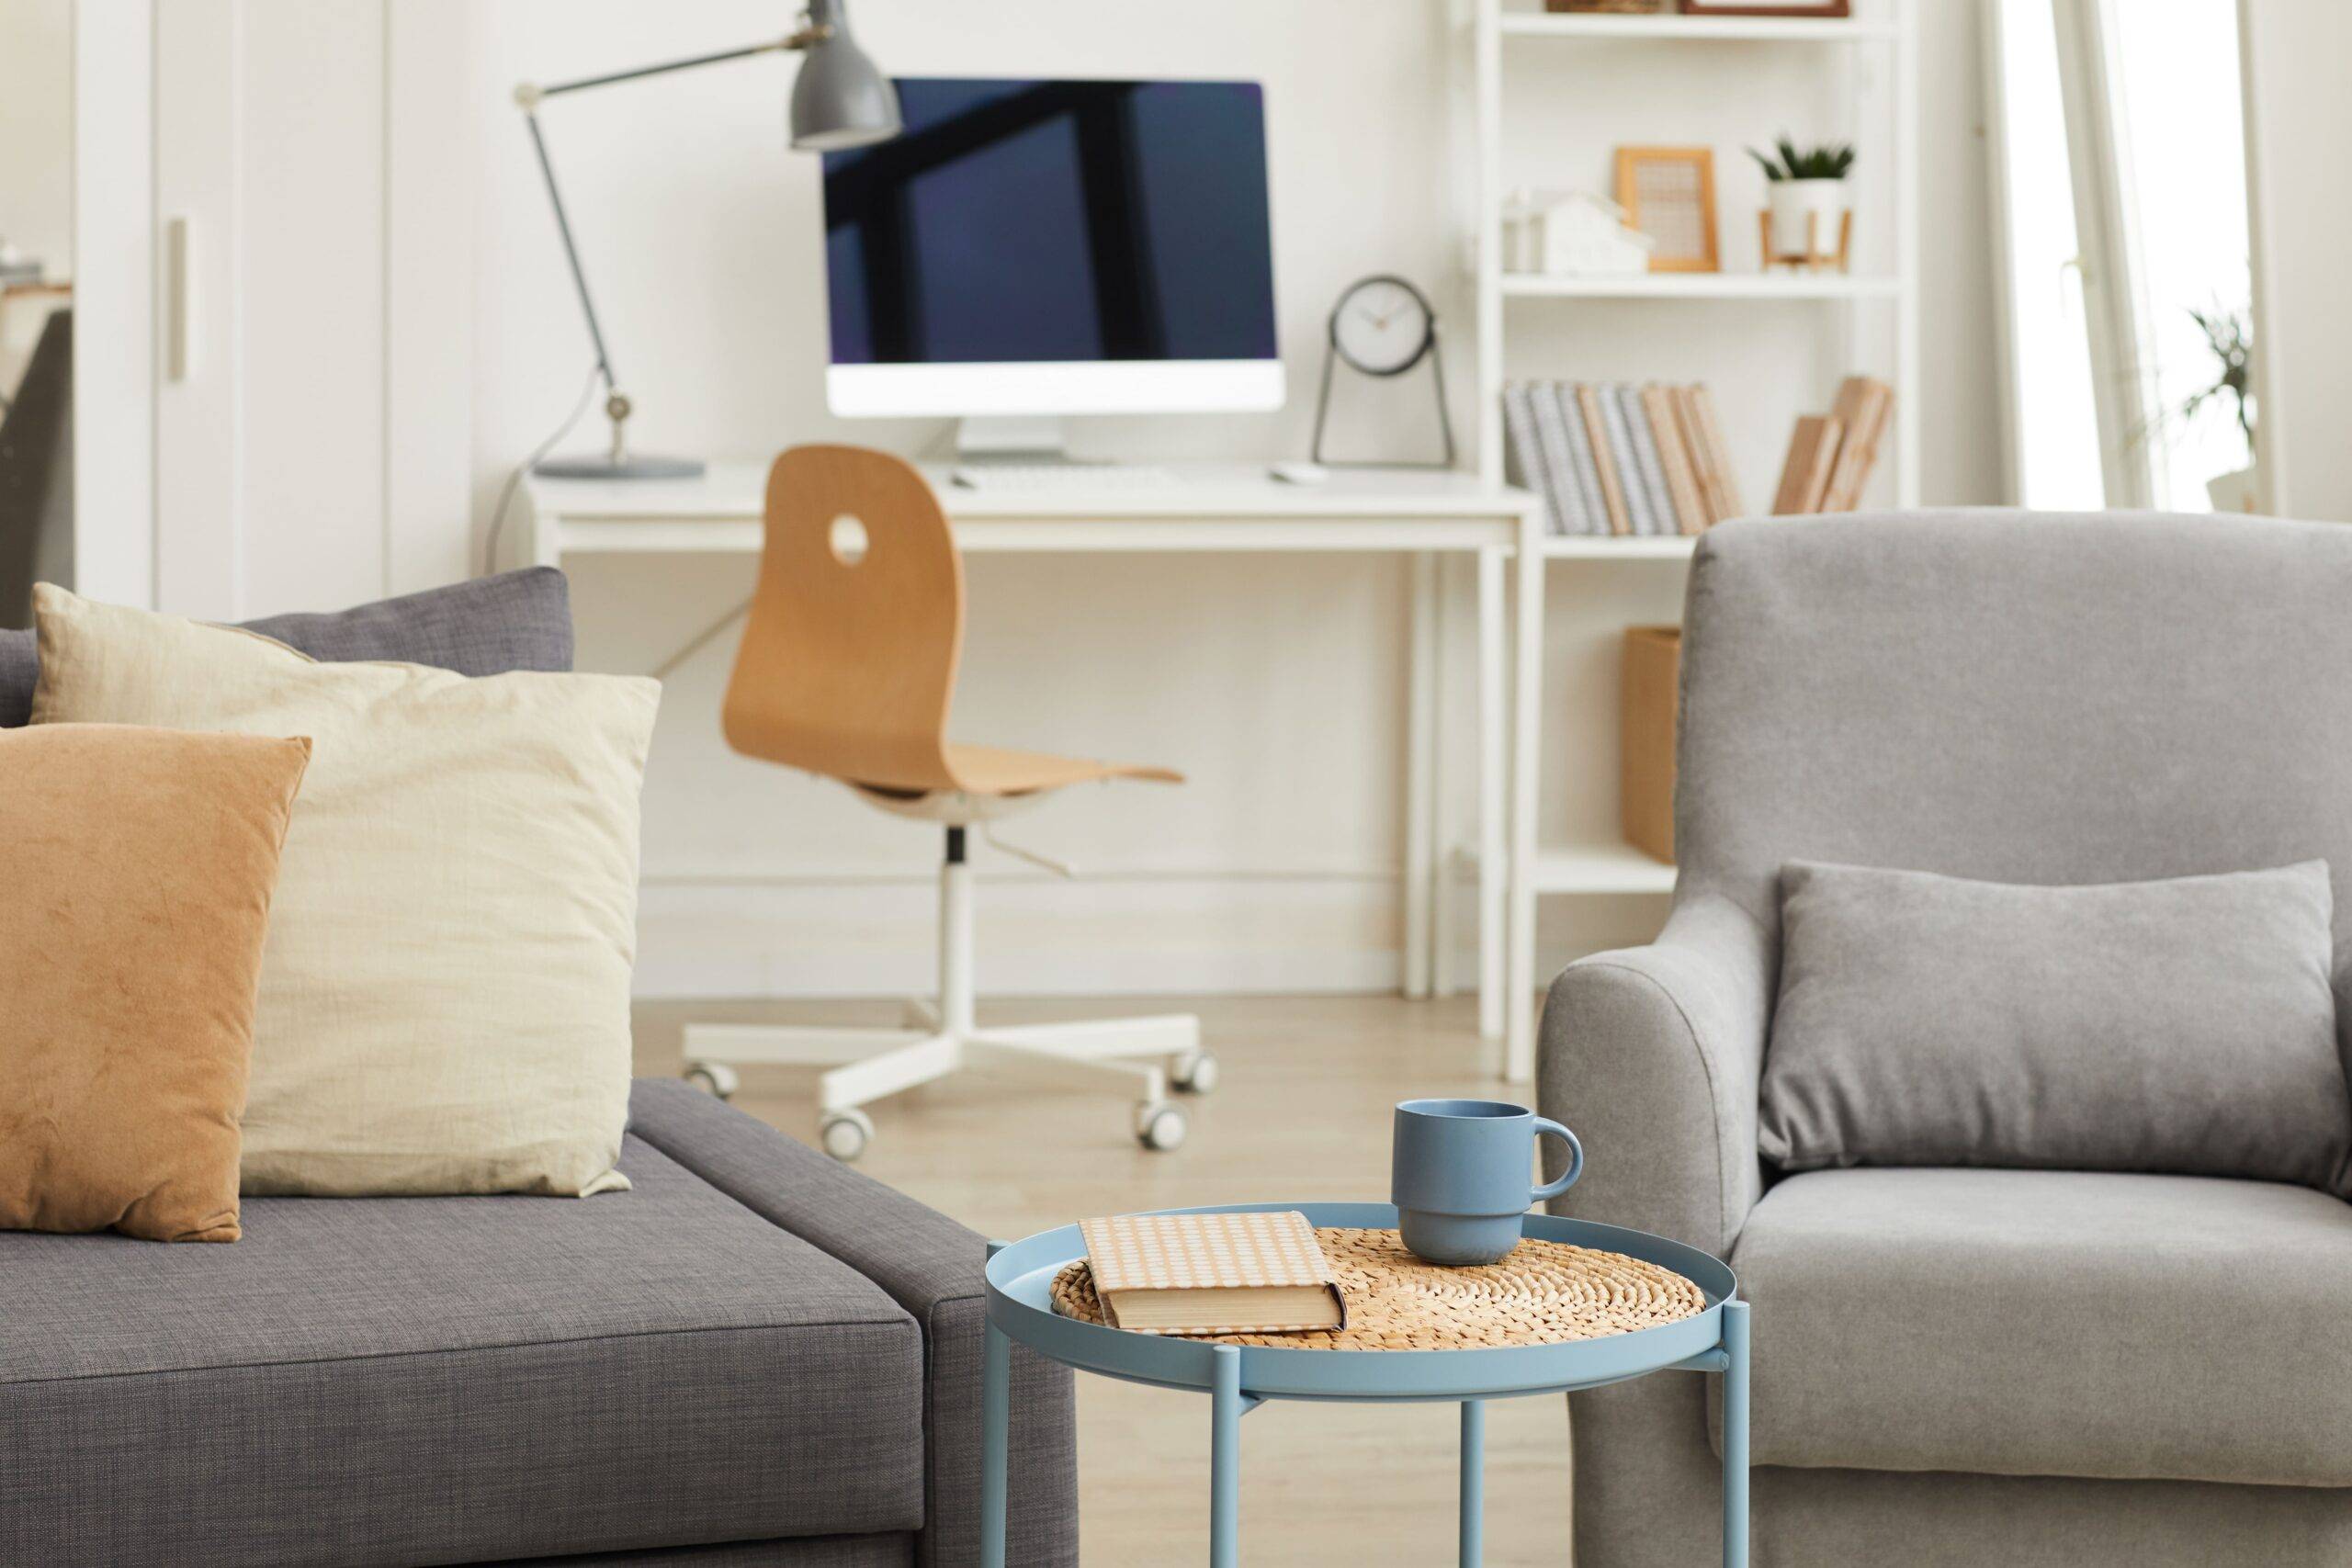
[1054,1229,1708,1349]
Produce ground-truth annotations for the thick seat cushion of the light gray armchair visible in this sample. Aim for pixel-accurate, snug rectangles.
[1717,1168,2352,1485]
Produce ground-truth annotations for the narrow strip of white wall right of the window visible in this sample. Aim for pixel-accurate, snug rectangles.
[2242,0,2352,522]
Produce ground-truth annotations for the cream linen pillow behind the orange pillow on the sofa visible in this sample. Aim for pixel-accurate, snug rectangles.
[33,585,661,1197]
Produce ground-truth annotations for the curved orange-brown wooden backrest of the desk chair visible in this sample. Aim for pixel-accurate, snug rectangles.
[722,446,965,790]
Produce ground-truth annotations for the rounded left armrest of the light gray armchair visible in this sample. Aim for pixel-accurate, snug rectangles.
[1536,896,1773,1256]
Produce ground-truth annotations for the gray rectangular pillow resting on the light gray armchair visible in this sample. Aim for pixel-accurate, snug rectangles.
[1757,861,2352,1194]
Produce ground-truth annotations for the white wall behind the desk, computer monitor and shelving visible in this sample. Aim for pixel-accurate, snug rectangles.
[454,0,1996,992]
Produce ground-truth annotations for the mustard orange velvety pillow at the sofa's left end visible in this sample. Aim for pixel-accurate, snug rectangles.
[0,724,311,1241]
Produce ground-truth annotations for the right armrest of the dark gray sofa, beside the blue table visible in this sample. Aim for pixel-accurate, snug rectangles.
[628,1079,1077,1568]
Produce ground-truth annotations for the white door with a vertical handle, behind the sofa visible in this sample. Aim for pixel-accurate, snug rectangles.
[80,0,473,618]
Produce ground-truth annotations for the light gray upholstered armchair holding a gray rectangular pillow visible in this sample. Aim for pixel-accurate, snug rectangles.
[1541,513,2352,1568]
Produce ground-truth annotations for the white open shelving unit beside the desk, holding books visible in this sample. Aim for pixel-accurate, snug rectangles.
[1456,0,1919,1077]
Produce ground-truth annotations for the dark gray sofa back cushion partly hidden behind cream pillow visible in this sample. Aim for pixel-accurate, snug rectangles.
[0,567,571,728]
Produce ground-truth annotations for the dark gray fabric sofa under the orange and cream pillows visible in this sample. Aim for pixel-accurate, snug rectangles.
[0,571,1077,1568]
